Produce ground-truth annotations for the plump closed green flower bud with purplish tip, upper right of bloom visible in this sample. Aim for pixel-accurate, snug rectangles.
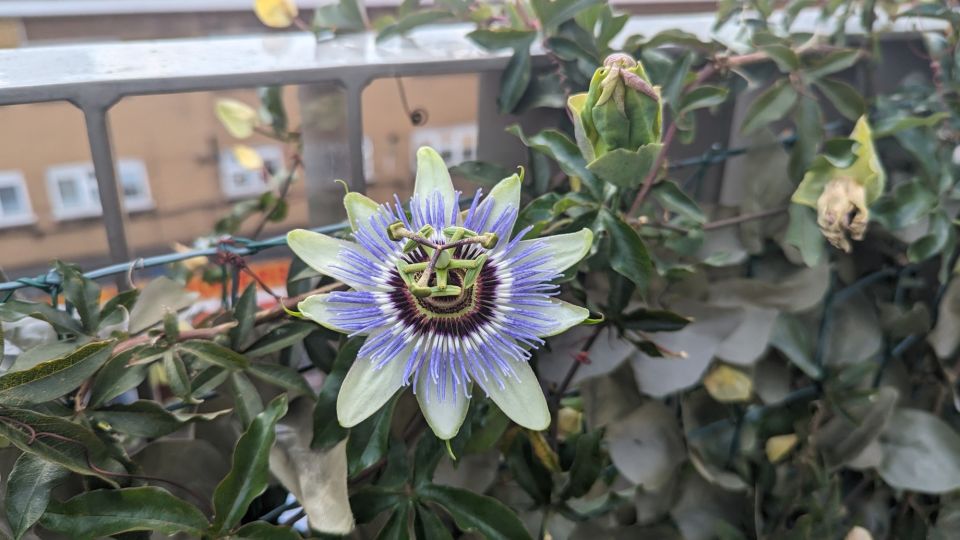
[568,53,662,162]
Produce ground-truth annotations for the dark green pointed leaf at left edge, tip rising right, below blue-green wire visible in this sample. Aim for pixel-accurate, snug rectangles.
[0,340,113,404]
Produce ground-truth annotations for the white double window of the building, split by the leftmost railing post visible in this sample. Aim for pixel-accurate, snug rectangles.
[47,159,153,220]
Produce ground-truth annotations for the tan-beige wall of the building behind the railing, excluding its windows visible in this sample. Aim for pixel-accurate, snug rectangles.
[0,75,476,277]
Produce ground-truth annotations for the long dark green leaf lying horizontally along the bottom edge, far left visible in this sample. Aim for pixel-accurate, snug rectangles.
[40,487,207,540]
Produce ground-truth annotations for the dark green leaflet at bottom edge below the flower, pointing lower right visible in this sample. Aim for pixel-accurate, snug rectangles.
[417,484,531,540]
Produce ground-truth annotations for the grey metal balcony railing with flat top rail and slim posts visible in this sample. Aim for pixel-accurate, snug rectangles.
[0,10,937,286]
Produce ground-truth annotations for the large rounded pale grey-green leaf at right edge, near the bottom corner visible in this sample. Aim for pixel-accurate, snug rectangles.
[877,408,960,495]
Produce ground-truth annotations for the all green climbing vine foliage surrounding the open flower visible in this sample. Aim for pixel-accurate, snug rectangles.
[0,0,960,539]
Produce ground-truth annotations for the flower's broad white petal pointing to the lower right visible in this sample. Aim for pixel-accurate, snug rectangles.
[486,361,550,431]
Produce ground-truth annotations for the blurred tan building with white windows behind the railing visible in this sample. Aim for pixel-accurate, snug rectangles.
[0,0,477,277]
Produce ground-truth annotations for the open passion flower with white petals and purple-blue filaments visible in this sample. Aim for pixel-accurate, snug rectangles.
[287,147,593,439]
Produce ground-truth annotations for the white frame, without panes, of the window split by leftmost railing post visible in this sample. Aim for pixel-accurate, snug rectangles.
[46,158,154,221]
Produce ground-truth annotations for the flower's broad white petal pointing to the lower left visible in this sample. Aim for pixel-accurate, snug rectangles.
[337,345,413,427]
